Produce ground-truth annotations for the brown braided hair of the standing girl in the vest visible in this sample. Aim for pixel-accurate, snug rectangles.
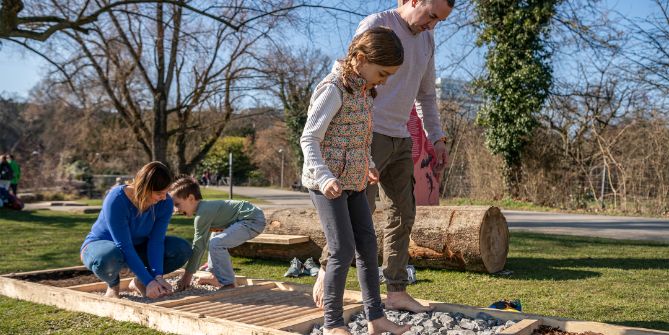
[341,27,404,98]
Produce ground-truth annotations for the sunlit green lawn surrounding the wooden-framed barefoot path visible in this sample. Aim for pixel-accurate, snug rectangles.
[0,211,669,334]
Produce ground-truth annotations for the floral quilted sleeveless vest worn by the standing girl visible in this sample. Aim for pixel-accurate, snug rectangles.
[303,71,373,191]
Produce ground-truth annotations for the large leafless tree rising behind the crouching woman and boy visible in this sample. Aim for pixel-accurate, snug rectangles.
[32,0,300,172]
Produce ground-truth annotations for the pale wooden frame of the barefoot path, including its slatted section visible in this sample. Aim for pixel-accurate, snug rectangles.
[0,266,669,335]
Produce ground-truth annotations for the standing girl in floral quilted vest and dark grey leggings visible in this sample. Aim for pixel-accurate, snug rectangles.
[300,27,411,334]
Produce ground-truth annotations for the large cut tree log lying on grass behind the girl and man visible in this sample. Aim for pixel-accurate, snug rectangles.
[230,206,509,273]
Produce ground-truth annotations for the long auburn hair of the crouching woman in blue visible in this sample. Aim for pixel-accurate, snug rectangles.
[132,161,174,213]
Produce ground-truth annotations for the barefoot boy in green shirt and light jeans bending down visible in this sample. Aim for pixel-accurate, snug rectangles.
[170,177,265,290]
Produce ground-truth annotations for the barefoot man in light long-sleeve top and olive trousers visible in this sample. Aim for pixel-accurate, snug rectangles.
[313,0,455,313]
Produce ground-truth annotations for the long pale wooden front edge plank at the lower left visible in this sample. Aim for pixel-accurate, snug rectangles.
[0,277,295,335]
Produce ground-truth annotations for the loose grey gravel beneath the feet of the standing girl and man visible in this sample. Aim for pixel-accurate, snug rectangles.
[310,310,516,335]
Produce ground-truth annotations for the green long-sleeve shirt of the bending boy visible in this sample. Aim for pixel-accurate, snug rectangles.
[186,200,264,273]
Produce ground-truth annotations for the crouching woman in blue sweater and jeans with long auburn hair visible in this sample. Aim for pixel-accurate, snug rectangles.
[81,162,191,299]
